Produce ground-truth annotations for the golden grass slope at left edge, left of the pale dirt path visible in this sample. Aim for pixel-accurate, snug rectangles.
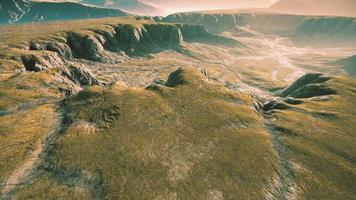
[0,105,56,190]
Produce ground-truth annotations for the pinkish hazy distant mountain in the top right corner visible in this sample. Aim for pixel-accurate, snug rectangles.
[270,0,356,16]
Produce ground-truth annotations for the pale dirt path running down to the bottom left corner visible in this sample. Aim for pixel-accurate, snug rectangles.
[1,108,63,199]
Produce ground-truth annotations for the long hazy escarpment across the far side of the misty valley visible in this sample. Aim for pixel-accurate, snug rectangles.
[160,13,356,46]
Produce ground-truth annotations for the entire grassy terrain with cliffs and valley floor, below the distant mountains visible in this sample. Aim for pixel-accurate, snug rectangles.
[0,15,356,200]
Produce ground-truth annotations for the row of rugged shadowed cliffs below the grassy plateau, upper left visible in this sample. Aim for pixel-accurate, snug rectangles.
[11,23,217,71]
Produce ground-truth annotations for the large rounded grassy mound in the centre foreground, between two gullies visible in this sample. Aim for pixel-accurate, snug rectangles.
[13,68,275,199]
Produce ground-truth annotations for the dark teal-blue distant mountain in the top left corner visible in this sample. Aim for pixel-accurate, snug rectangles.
[0,0,128,24]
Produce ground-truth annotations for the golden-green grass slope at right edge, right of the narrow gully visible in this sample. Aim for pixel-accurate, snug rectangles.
[274,77,356,199]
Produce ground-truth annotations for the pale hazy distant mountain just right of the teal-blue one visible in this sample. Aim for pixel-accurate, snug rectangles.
[81,0,164,15]
